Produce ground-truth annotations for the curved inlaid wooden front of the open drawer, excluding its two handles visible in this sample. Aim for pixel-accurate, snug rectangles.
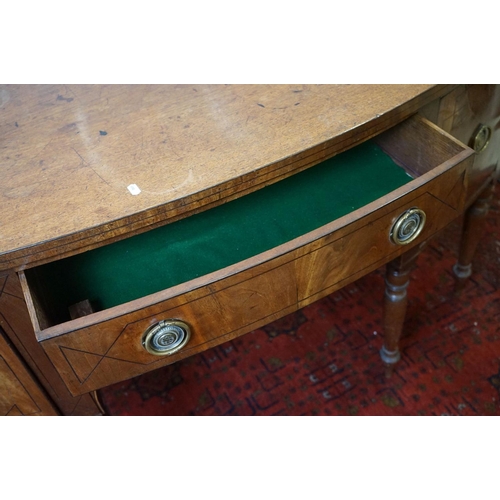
[42,180,464,394]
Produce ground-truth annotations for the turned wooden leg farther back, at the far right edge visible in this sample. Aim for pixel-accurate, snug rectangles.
[453,183,495,293]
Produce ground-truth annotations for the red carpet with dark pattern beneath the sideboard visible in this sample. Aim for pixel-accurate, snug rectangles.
[100,183,500,415]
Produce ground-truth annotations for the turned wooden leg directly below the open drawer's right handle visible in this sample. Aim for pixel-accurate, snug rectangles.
[380,244,424,377]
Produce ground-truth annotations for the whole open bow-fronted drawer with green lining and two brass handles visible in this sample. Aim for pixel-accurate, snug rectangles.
[19,116,473,395]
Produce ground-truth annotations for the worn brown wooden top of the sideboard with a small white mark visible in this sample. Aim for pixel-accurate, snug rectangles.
[0,85,448,271]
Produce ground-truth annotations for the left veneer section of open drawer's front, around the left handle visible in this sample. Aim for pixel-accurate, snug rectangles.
[42,263,297,394]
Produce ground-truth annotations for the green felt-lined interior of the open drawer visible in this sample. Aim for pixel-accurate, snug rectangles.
[21,115,463,329]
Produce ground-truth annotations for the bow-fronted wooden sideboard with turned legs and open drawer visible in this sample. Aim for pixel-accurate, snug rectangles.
[0,85,500,415]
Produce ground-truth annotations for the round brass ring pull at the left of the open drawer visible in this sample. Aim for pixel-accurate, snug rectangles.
[142,319,191,356]
